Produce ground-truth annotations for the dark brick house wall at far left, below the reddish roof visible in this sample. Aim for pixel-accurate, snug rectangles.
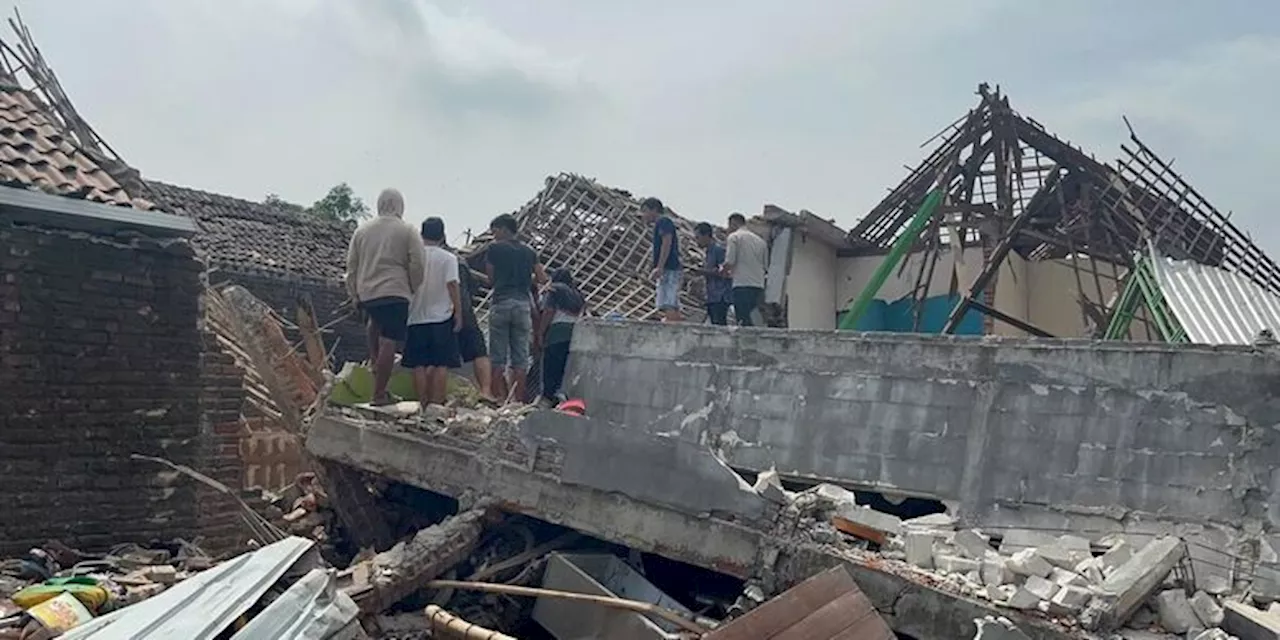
[0,221,241,554]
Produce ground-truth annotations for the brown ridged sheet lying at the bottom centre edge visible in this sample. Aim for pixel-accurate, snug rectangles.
[707,566,895,640]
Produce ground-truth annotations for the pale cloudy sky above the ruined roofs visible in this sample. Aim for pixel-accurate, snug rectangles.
[18,0,1280,255]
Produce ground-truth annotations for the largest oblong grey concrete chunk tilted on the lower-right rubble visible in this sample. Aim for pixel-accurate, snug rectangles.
[1080,536,1185,631]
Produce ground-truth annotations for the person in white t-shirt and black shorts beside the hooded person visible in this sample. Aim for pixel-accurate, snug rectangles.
[401,218,462,406]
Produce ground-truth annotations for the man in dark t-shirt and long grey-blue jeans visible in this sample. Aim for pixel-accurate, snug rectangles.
[485,214,547,402]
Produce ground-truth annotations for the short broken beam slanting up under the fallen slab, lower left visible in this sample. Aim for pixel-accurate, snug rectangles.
[347,506,488,614]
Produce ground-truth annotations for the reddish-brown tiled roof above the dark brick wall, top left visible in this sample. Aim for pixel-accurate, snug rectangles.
[0,83,154,210]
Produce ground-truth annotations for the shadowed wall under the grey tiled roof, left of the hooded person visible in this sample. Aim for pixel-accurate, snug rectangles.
[209,265,367,369]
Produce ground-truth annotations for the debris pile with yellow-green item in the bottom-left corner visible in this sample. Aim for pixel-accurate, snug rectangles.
[0,540,214,640]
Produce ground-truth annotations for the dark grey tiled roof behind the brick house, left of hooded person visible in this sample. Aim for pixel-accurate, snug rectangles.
[146,180,353,279]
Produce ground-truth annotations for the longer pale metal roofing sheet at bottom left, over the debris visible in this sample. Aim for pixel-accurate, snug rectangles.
[59,536,315,640]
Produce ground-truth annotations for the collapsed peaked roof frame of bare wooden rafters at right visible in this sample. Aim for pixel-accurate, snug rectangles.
[846,83,1280,334]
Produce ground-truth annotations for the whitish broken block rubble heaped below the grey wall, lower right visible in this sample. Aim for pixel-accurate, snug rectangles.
[783,481,1280,640]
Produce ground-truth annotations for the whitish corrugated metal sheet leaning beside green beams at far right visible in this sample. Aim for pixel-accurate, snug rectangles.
[1151,244,1280,344]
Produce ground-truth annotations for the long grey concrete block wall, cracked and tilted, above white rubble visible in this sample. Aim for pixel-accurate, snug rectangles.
[568,321,1280,581]
